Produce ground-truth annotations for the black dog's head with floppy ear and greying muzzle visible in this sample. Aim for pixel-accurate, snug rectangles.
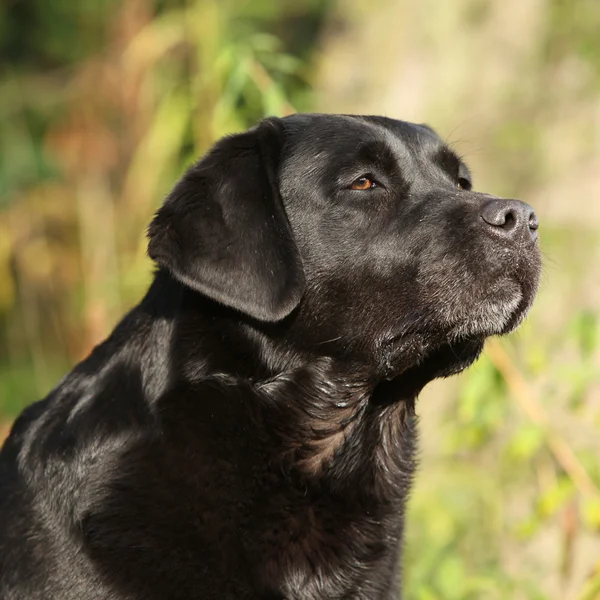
[149,115,540,387]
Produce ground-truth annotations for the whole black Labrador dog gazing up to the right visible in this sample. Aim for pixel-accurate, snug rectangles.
[0,115,540,600]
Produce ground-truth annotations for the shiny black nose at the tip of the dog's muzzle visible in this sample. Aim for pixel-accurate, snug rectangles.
[481,198,539,240]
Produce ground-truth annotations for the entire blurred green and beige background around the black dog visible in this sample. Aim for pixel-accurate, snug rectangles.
[0,0,600,600]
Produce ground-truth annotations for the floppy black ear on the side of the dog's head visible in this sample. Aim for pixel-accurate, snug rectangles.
[148,119,304,321]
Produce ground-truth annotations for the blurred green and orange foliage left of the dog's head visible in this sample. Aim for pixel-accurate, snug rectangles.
[0,0,328,404]
